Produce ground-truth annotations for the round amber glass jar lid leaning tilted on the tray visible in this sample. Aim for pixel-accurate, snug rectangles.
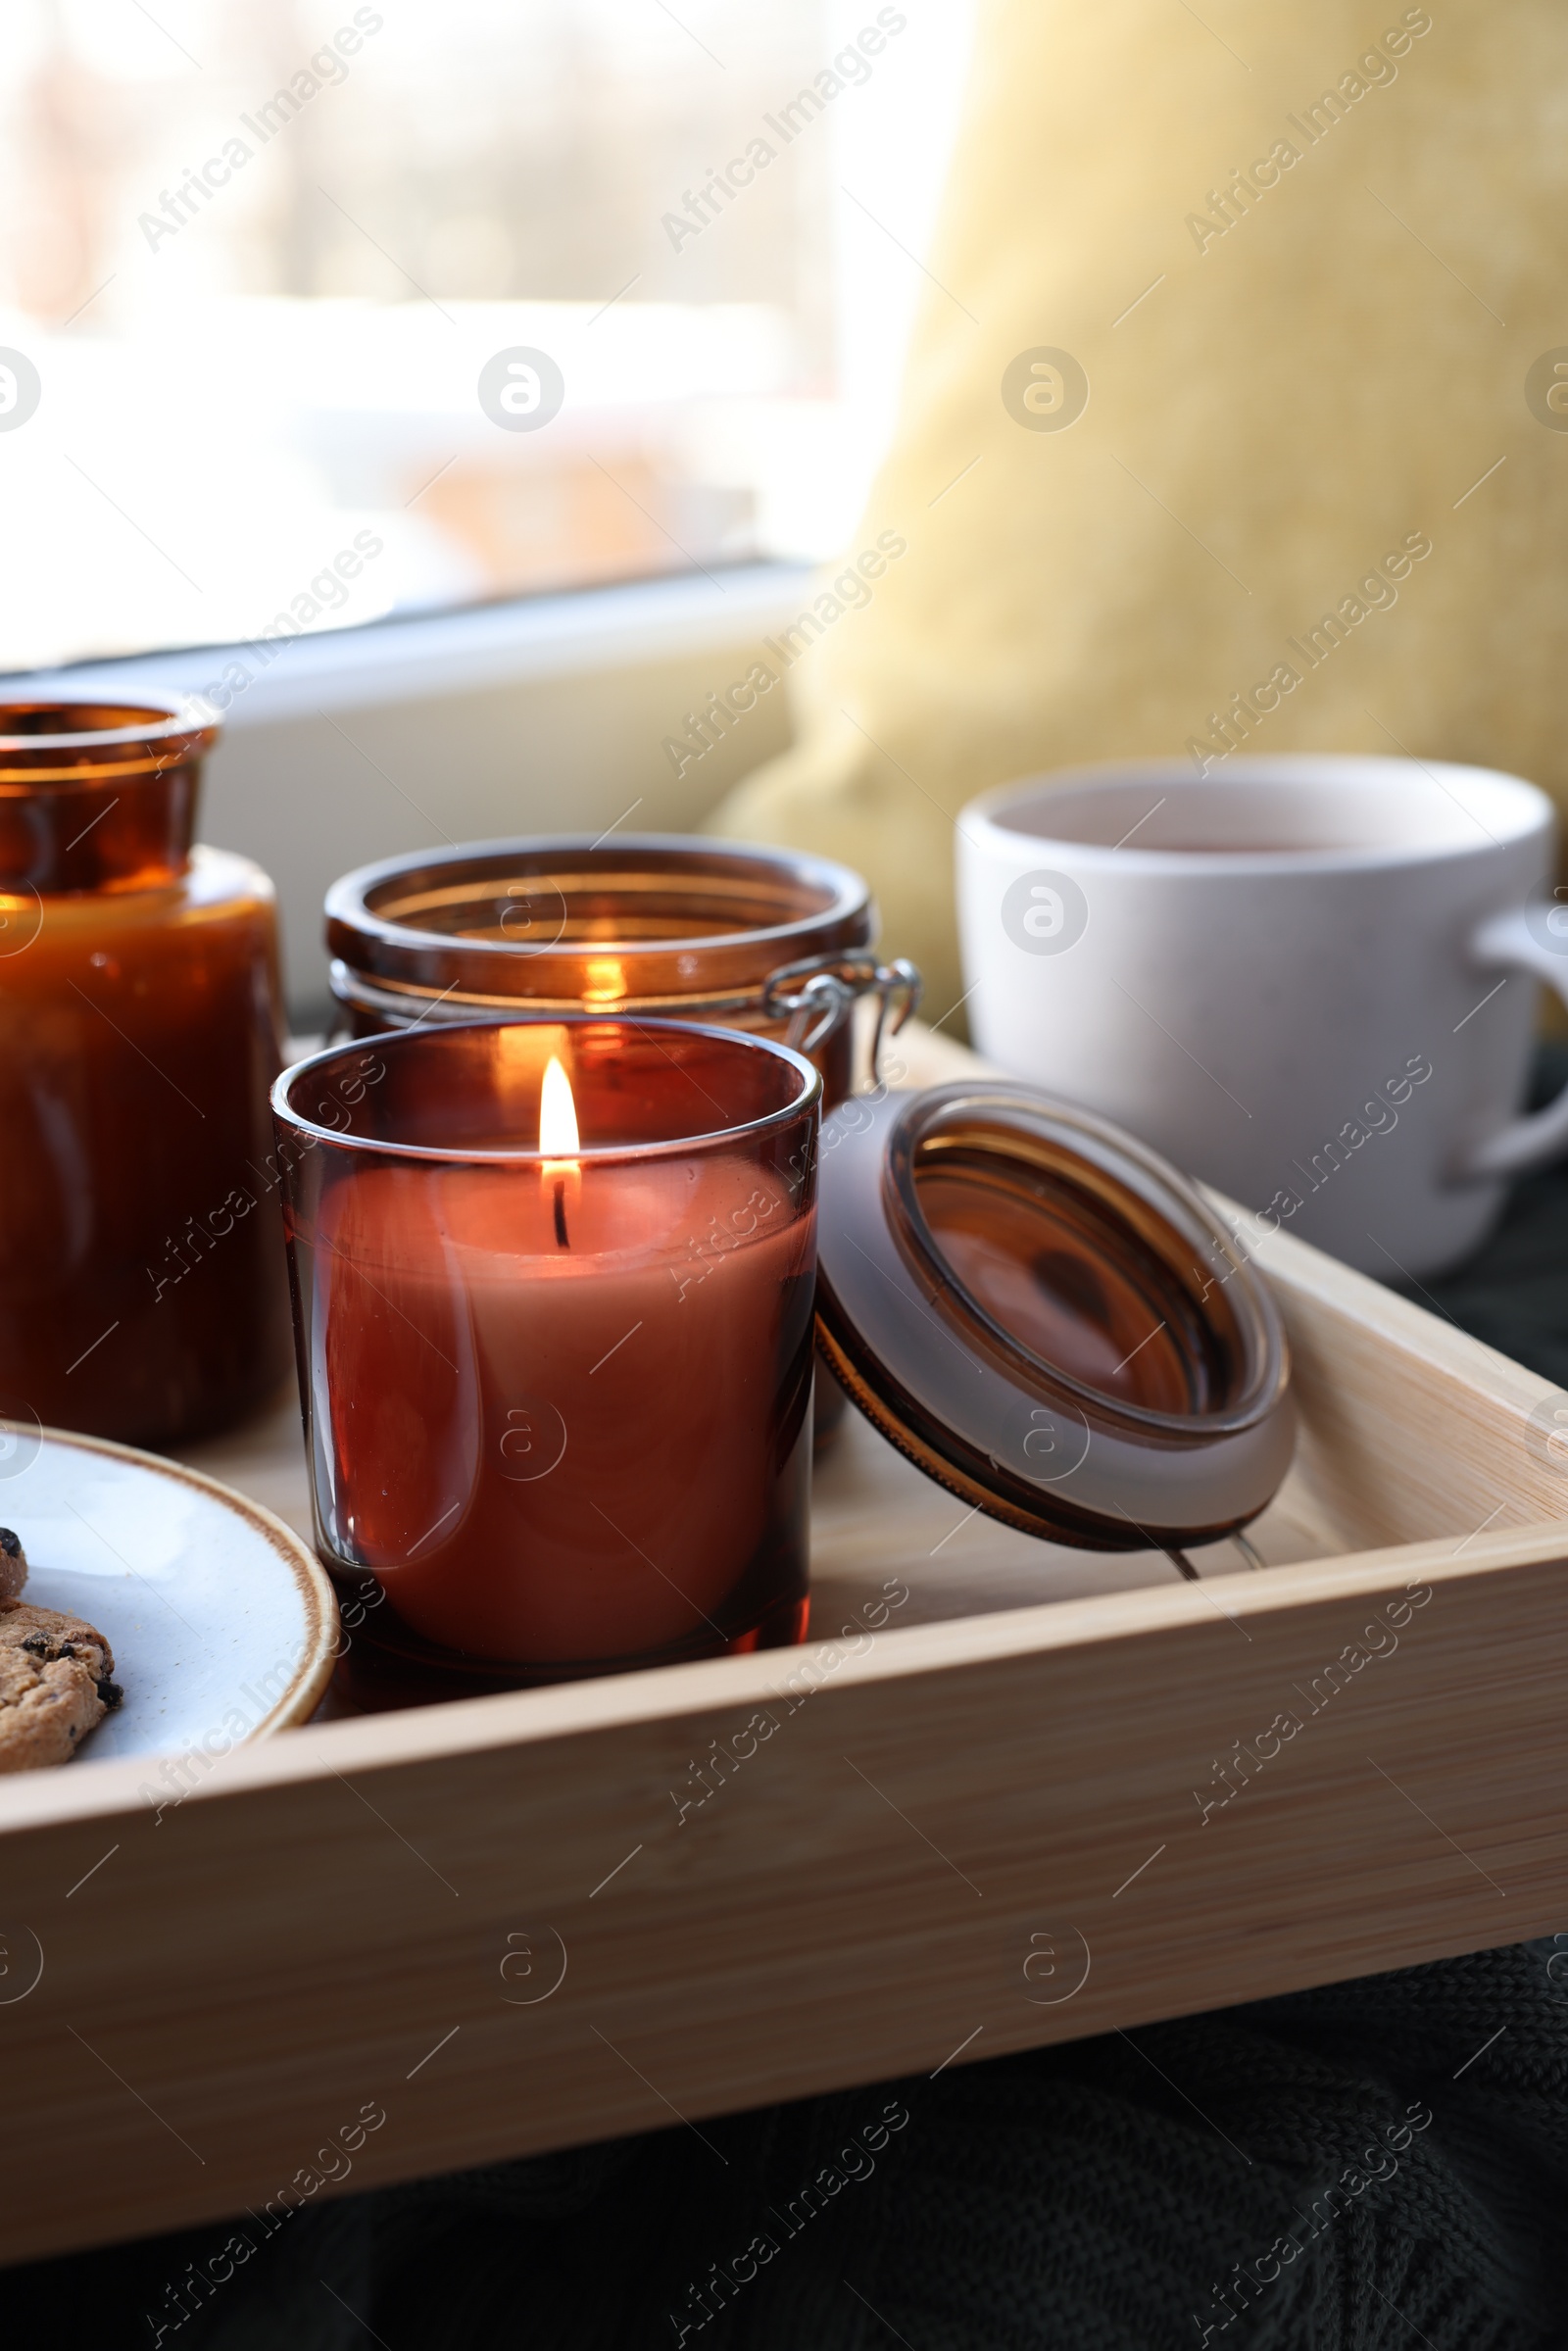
[818,1079,1296,1551]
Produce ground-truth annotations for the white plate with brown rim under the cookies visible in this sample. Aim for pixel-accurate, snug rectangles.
[0,1422,338,1787]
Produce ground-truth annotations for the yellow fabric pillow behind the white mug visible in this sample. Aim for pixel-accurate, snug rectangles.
[712,0,1568,1018]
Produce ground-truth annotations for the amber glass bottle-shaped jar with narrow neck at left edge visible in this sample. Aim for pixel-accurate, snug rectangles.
[0,701,289,1445]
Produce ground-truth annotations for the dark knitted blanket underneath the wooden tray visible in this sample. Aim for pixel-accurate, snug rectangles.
[12,1086,1568,2351]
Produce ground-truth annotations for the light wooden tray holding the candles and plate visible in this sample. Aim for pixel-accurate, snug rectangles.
[0,1039,1568,2259]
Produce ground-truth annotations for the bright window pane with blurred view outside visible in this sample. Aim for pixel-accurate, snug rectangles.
[0,0,966,672]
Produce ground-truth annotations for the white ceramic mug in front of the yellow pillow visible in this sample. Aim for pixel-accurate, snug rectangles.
[956,755,1568,1279]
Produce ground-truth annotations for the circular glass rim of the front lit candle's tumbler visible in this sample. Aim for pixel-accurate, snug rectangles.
[268,1013,823,1168]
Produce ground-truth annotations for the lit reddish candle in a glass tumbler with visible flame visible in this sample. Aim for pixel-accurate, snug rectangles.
[272,1018,823,1681]
